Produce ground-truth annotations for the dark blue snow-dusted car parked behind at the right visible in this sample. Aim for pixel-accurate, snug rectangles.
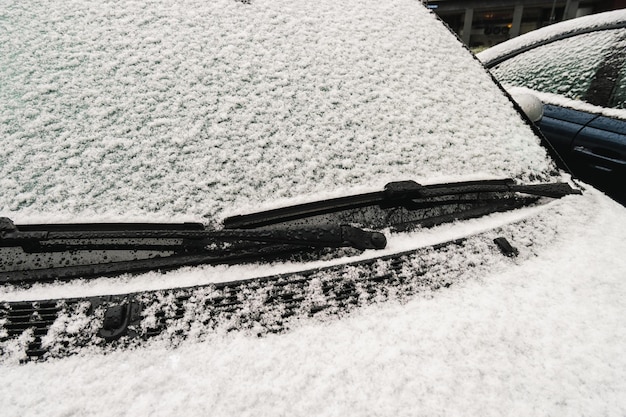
[477,9,626,204]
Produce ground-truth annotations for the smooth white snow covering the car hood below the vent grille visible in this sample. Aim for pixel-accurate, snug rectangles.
[0,192,626,416]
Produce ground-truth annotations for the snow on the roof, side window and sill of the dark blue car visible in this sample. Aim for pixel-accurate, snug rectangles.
[476,9,626,120]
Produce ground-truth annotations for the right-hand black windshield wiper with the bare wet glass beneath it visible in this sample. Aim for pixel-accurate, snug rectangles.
[224,179,580,230]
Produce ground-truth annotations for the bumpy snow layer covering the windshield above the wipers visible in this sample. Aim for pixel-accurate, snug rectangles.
[0,0,555,222]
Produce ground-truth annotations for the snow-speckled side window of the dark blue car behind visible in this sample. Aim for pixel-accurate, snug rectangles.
[492,31,619,104]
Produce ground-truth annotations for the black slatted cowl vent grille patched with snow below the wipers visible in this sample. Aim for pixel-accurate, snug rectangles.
[0,231,514,361]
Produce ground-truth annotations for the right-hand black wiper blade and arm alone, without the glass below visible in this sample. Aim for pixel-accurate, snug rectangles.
[224,179,580,229]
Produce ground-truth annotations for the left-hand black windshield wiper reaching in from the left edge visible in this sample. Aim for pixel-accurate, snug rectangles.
[0,218,387,284]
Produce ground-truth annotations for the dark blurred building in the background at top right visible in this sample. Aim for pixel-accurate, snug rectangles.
[424,0,626,50]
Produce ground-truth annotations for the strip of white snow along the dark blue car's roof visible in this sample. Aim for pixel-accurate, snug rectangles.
[476,9,626,65]
